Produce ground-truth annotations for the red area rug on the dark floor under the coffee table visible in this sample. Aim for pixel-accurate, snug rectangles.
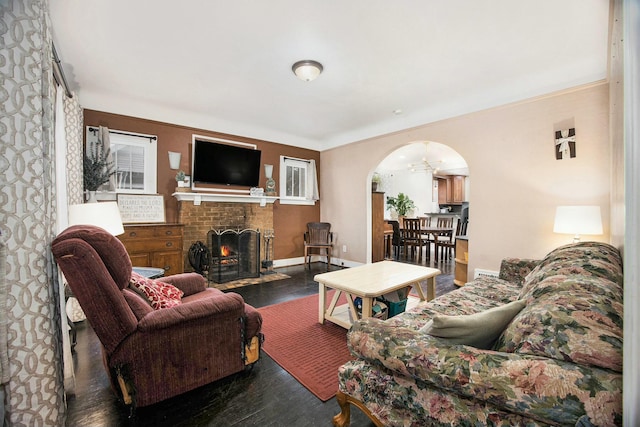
[258,292,353,402]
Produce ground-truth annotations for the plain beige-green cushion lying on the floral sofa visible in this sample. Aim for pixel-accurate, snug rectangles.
[420,300,525,349]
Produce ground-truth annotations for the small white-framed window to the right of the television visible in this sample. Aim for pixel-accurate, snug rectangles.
[280,156,318,205]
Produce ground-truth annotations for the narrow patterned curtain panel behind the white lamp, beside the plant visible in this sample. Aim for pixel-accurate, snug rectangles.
[64,95,84,205]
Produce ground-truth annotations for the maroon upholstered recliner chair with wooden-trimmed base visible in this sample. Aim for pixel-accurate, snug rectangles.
[51,225,262,406]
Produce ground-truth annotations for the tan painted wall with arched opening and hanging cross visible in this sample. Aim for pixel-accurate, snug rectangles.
[320,83,608,272]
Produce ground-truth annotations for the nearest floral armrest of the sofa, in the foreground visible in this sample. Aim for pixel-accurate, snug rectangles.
[347,318,622,425]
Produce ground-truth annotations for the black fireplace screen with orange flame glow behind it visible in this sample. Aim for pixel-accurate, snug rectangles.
[207,229,260,283]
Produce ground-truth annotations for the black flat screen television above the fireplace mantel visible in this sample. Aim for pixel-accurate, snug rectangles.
[191,139,261,187]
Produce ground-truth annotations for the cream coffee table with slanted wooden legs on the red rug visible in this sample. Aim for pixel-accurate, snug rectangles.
[313,261,440,329]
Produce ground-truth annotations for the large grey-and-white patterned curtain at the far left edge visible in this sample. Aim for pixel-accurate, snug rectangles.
[0,0,65,426]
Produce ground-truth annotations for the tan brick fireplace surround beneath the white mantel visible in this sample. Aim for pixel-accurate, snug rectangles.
[177,193,273,271]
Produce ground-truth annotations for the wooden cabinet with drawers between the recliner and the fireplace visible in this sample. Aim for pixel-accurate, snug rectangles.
[118,224,184,275]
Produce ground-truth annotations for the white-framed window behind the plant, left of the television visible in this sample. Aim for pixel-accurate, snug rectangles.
[87,126,158,194]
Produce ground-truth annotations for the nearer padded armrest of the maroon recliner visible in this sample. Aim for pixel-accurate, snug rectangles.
[138,293,244,332]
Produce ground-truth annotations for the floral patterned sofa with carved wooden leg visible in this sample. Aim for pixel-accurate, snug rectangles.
[333,242,623,426]
